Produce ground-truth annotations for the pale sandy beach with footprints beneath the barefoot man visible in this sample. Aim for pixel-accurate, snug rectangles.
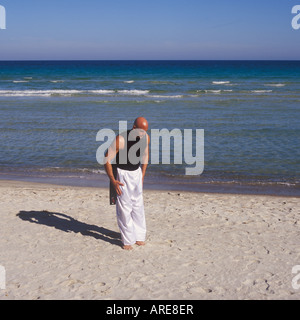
[0,180,300,300]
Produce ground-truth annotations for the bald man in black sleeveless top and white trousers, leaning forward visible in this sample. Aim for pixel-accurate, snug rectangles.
[105,117,150,250]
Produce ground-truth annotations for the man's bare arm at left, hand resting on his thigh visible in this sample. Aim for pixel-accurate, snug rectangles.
[104,136,124,196]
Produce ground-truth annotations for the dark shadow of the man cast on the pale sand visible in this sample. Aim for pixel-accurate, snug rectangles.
[17,211,122,246]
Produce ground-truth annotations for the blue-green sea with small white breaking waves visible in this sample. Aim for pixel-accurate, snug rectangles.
[0,61,300,196]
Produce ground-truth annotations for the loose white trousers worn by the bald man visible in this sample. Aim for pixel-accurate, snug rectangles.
[116,168,146,245]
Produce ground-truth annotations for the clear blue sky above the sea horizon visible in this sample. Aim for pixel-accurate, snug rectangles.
[0,0,300,60]
